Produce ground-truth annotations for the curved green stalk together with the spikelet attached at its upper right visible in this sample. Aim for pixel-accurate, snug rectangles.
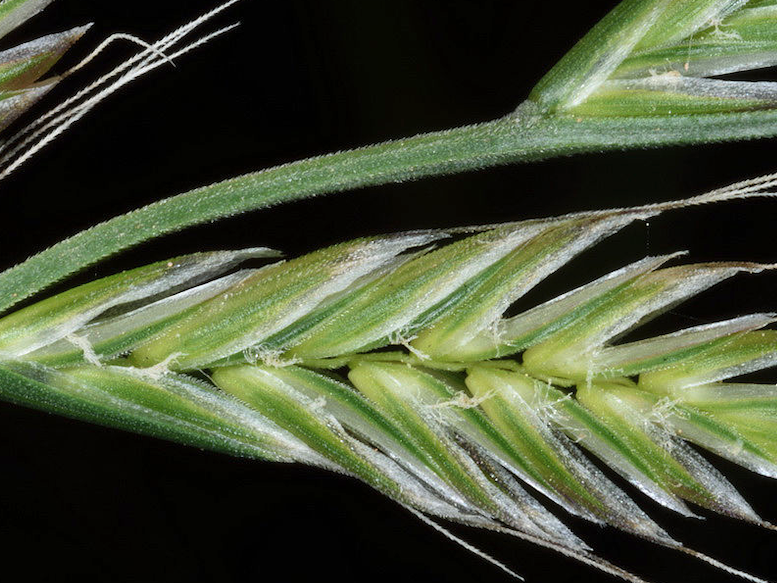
[7,0,777,311]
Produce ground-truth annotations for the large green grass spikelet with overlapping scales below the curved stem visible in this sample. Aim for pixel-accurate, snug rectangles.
[0,186,777,577]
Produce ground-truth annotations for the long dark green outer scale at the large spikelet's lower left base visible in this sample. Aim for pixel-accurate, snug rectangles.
[0,363,293,461]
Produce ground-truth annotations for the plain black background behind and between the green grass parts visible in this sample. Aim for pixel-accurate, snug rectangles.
[0,0,777,583]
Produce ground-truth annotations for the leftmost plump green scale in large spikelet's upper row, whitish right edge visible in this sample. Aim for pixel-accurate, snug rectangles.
[131,234,430,370]
